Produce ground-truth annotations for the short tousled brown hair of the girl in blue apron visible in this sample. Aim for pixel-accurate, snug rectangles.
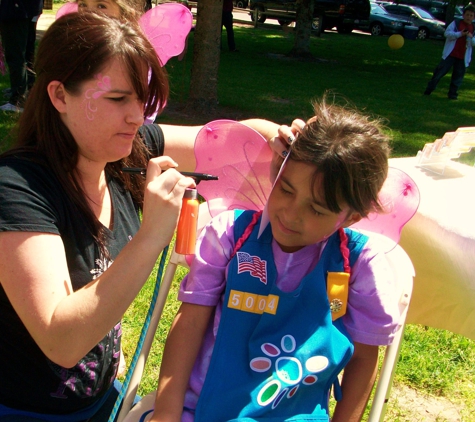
[289,95,389,217]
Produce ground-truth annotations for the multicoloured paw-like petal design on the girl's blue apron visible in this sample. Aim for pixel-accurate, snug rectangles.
[250,335,329,409]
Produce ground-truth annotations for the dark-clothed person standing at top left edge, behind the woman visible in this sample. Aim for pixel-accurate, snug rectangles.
[0,0,43,112]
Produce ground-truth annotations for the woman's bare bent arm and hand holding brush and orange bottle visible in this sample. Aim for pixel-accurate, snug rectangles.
[0,157,194,367]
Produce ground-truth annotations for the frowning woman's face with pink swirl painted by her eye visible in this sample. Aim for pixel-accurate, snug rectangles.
[56,59,147,171]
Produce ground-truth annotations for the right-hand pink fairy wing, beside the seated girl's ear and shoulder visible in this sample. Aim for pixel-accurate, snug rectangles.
[352,167,420,243]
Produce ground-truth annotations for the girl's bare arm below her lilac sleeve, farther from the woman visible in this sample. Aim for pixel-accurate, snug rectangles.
[332,342,379,422]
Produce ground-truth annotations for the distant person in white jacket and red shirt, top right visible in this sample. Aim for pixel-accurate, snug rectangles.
[424,4,475,100]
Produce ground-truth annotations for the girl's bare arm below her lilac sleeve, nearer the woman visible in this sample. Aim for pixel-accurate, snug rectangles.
[150,303,214,422]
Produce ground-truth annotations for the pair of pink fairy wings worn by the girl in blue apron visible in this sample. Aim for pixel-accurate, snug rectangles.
[195,120,420,250]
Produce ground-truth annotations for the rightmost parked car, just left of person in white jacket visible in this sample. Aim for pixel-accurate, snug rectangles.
[383,3,445,39]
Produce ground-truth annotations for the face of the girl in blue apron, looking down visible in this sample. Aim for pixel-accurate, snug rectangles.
[268,159,361,253]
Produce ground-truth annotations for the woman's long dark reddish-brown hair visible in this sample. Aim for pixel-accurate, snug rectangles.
[10,13,168,256]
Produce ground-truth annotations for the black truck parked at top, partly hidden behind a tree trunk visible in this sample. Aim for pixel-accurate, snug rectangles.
[249,0,371,33]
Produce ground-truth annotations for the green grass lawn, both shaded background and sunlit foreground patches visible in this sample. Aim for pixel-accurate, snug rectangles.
[0,9,475,421]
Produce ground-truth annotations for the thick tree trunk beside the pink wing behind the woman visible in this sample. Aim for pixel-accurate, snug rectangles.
[186,0,223,114]
